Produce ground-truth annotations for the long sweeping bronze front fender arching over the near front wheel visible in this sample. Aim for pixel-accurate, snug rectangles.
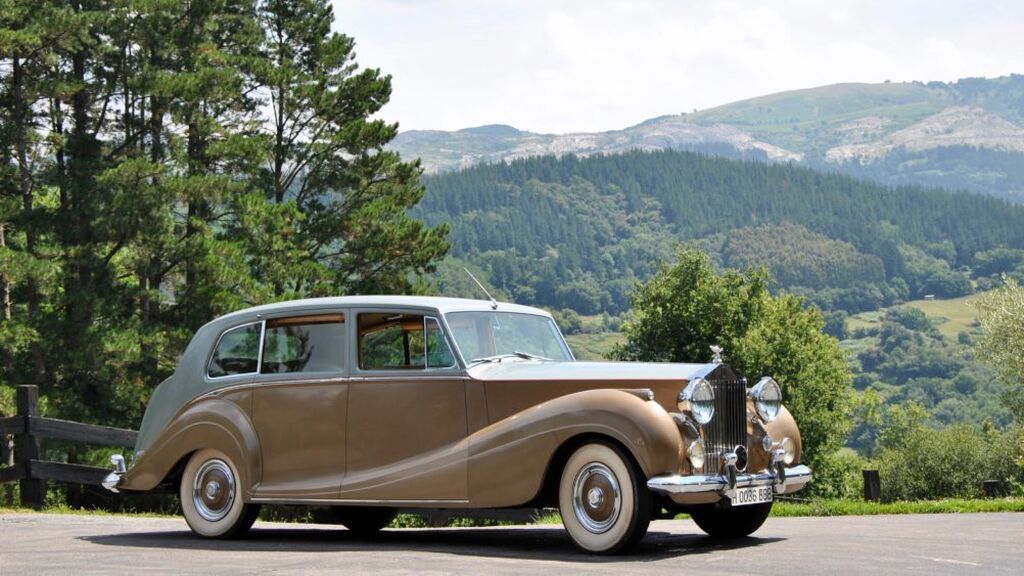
[468,389,683,507]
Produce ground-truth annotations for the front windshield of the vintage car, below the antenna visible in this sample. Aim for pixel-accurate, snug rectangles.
[444,312,572,364]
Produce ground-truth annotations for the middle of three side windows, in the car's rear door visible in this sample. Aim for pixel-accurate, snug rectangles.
[260,314,345,374]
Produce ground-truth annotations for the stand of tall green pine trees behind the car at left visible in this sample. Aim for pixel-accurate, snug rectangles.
[0,0,447,426]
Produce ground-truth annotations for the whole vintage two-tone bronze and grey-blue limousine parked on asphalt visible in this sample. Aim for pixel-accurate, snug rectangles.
[105,296,811,552]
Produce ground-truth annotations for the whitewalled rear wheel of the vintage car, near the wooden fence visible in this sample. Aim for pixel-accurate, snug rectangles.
[180,449,260,538]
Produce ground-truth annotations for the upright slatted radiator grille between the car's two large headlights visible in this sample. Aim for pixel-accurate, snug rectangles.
[703,379,746,475]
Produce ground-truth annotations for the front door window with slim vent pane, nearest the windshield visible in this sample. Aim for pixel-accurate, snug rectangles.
[358,313,455,370]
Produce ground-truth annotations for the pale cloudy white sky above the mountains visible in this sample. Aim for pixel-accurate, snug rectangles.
[333,0,1024,133]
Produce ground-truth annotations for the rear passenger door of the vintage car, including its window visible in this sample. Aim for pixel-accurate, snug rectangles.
[253,311,348,501]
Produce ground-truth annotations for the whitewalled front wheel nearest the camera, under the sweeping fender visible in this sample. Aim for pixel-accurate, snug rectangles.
[558,443,651,554]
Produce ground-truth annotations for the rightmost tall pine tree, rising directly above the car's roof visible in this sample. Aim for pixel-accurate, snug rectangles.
[248,0,449,297]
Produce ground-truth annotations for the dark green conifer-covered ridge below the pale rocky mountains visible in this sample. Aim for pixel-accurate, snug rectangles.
[416,151,1024,314]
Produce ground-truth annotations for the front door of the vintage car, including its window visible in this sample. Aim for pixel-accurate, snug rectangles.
[341,308,468,502]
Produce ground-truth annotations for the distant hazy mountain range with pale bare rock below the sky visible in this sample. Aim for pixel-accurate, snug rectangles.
[392,75,1024,203]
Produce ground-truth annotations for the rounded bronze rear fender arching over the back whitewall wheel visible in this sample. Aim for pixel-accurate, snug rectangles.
[118,398,260,499]
